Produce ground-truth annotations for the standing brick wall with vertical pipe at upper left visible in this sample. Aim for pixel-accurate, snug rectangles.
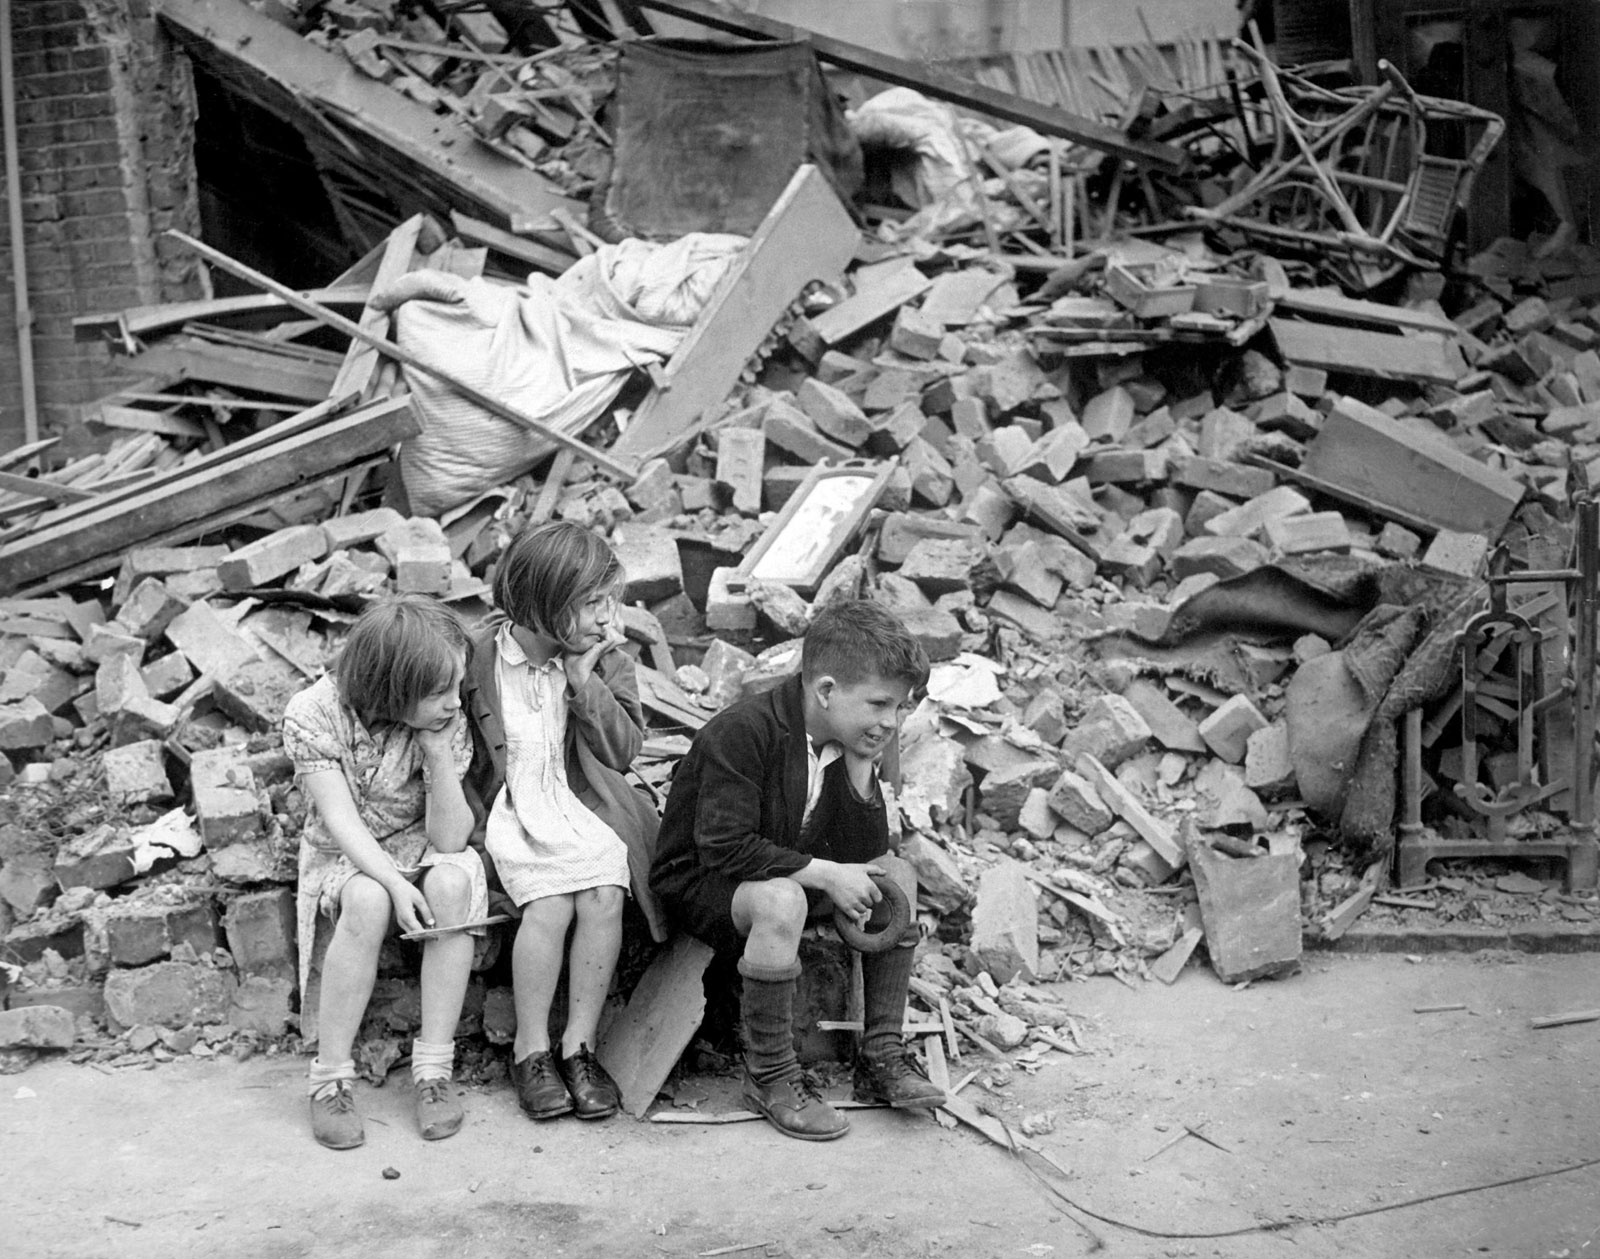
[0,0,205,451]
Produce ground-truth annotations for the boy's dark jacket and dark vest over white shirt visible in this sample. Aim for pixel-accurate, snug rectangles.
[650,677,899,902]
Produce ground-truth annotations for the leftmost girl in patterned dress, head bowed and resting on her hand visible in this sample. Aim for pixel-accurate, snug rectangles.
[283,595,488,1150]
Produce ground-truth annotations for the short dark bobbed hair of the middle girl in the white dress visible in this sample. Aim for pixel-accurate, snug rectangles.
[494,520,622,646]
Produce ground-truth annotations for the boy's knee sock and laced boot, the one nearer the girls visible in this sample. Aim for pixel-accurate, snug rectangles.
[739,958,850,1141]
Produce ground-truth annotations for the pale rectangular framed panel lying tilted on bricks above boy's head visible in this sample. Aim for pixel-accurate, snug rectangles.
[731,461,894,598]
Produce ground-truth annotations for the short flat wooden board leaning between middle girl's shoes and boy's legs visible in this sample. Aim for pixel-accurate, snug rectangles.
[595,934,712,1118]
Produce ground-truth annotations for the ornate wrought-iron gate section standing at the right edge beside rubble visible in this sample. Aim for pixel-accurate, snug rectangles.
[1398,496,1600,889]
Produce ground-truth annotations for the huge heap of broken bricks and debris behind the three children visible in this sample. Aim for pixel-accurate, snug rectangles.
[0,0,1600,1081]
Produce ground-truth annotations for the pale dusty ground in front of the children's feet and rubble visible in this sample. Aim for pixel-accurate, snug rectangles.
[0,953,1600,1259]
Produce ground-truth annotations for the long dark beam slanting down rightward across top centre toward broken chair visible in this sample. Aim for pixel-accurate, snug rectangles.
[624,0,1189,171]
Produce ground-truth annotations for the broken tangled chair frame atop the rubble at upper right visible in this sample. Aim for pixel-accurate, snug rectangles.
[1187,42,1506,290]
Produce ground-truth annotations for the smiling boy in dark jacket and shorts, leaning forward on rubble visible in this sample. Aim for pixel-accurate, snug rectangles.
[651,600,944,1141]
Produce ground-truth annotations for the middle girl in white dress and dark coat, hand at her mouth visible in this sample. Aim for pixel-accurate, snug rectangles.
[464,522,662,1120]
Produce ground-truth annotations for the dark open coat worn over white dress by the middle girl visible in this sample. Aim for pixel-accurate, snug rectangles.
[461,616,667,941]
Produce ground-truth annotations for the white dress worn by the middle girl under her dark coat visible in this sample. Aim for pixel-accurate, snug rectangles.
[483,624,627,905]
